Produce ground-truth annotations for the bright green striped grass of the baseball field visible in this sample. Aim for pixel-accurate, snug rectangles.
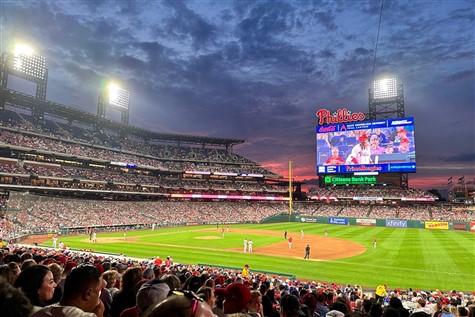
[44,222,475,292]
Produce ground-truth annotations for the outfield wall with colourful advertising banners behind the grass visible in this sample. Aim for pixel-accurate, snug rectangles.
[262,214,475,232]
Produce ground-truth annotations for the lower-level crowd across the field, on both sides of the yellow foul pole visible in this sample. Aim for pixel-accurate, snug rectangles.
[1,192,475,237]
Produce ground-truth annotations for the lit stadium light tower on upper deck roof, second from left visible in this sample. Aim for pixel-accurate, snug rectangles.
[97,82,130,125]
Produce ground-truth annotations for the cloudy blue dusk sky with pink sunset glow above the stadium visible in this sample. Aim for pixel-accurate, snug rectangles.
[0,0,475,189]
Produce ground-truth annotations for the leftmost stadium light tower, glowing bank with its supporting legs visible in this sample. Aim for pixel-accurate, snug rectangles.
[0,44,48,109]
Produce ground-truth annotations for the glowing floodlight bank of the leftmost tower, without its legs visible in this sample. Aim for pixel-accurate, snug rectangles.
[13,45,46,80]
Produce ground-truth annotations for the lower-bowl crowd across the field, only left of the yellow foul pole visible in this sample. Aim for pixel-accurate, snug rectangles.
[2,198,287,237]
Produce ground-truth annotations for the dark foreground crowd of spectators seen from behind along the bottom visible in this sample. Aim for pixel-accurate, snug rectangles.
[0,245,475,317]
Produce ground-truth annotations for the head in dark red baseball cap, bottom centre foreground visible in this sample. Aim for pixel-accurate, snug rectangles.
[215,282,252,314]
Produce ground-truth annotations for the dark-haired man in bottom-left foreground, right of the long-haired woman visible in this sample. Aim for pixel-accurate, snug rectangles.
[32,264,104,317]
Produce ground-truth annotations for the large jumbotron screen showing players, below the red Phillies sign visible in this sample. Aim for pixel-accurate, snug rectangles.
[316,118,416,174]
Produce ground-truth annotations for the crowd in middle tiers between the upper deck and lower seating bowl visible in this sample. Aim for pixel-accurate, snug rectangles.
[0,161,286,195]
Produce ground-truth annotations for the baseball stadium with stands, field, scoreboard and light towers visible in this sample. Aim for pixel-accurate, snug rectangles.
[0,43,475,314]
